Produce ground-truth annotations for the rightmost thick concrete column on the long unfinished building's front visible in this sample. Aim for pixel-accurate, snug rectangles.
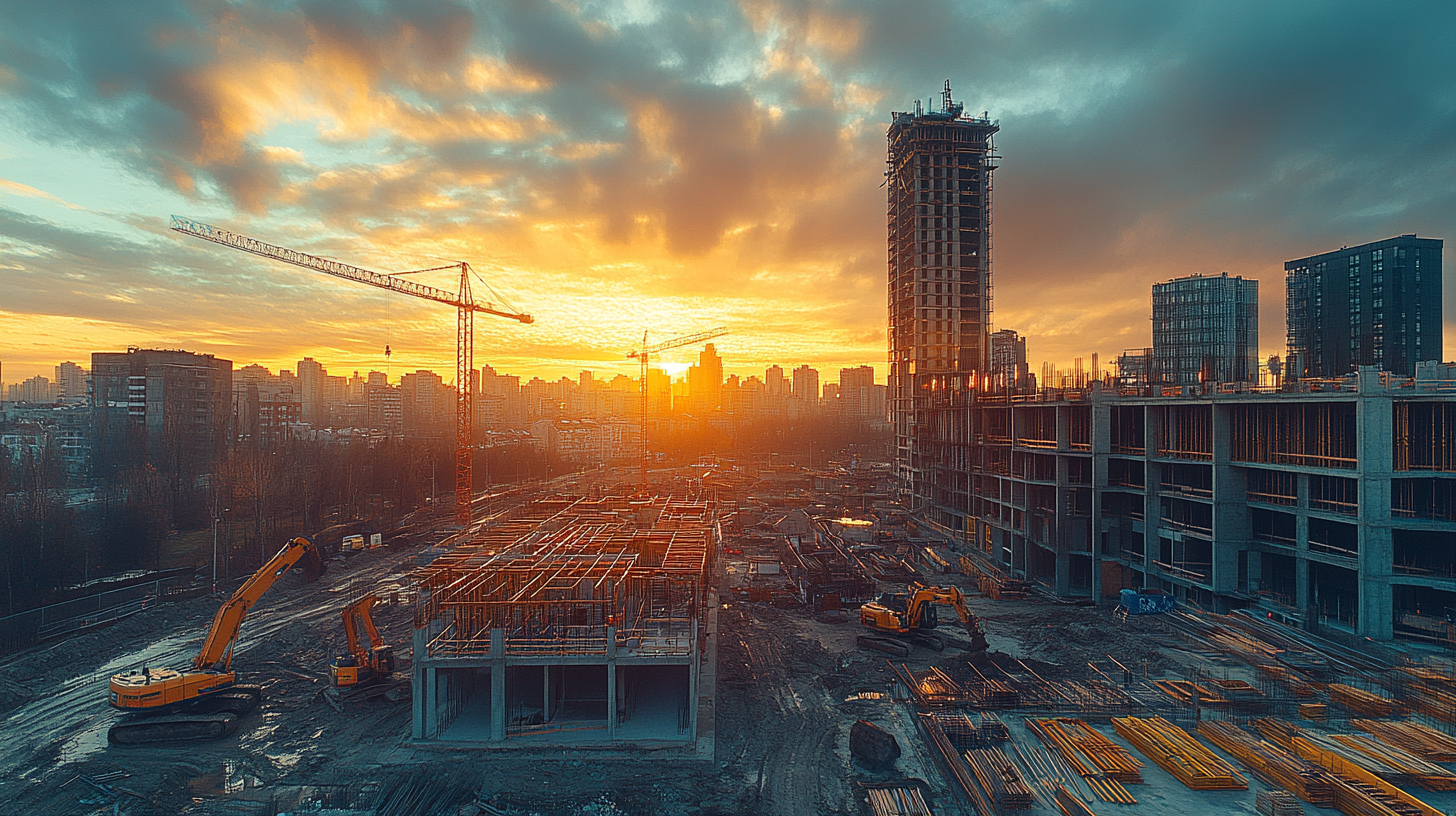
[1356,393,1395,640]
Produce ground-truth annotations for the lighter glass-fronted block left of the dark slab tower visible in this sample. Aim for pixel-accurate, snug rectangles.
[1153,272,1259,386]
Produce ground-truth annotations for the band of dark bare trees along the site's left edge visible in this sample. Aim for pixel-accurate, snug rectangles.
[0,439,561,615]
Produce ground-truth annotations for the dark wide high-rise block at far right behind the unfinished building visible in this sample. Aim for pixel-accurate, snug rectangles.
[1284,235,1444,379]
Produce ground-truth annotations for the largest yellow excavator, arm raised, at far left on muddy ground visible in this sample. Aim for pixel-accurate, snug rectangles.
[106,538,323,745]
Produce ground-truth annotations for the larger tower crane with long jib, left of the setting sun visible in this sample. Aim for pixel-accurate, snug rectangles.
[172,216,536,529]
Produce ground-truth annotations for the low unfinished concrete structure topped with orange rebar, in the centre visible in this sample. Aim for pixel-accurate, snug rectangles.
[411,497,719,748]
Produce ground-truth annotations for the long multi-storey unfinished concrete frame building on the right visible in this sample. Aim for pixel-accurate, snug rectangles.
[964,369,1456,640]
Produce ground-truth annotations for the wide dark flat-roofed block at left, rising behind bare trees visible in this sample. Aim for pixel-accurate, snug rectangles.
[90,348,233,475]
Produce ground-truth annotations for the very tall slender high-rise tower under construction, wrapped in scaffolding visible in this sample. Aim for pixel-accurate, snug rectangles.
[885,82,1000,530]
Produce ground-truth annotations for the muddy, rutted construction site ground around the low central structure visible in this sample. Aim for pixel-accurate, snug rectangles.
[14,521,1456,816]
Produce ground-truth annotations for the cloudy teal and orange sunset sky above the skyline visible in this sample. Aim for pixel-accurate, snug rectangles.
[0,0,1456,382]
